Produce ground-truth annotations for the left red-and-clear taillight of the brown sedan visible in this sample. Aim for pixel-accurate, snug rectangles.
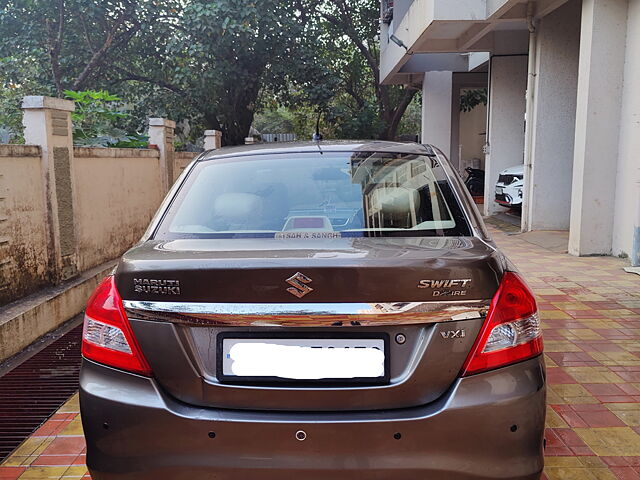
[82,276,151,376]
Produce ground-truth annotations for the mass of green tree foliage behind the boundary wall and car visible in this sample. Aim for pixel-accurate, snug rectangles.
[0,0,415,145]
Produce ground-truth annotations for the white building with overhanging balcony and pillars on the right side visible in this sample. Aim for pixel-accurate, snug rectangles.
[380,0,640,265]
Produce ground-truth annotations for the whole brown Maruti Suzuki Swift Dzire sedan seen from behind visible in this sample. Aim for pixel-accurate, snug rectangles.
[80,142,546,480]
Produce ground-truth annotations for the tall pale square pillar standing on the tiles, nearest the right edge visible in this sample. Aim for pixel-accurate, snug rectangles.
[569,0,624,255]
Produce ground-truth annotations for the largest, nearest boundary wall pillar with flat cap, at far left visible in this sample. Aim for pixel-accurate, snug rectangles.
[22,96,77,283]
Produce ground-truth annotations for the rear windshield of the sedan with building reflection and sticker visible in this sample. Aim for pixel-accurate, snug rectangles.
[154,152,469,239]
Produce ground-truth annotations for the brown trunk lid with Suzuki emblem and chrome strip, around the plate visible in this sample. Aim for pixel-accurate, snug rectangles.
[116,237,504,410]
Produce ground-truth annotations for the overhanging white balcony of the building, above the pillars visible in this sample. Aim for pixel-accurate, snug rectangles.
[380,0,566,84]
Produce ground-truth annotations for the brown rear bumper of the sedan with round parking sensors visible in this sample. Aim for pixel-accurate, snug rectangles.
[80,357,545,480]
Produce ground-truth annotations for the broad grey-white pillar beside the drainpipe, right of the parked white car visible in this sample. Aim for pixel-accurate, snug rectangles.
[522,0,581,230]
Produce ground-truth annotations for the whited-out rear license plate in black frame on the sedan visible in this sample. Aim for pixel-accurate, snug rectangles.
[218,337,386,380]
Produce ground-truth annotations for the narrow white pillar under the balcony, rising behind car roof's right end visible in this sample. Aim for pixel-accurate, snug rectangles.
[422,72,453,158]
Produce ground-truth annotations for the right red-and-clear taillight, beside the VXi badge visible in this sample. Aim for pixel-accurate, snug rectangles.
[462,272,542,376]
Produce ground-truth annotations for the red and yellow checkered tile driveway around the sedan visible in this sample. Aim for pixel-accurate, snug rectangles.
[0,229,640,480]
